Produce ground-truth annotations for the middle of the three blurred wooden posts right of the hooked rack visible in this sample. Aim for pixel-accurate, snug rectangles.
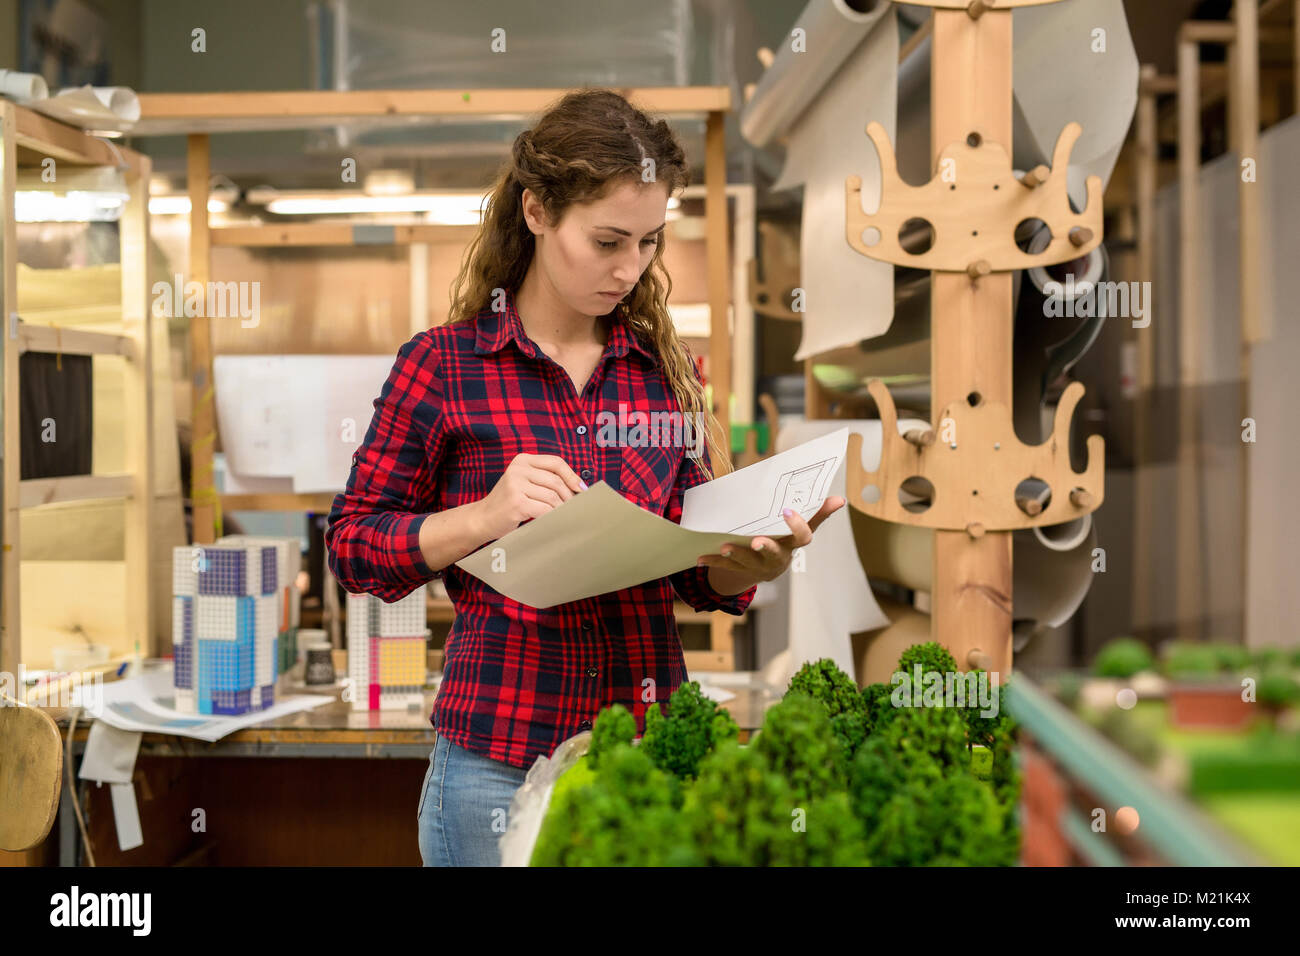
[1175,29,1204,639]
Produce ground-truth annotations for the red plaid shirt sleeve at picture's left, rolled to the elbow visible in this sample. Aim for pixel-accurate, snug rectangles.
[325,332,445,604]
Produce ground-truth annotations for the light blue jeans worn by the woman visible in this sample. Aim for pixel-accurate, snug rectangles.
[416,734,528,866]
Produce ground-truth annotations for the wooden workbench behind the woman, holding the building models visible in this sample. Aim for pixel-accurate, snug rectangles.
[49,669,779,866]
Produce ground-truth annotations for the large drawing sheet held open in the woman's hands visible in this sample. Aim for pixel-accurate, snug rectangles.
[456,428,849,607]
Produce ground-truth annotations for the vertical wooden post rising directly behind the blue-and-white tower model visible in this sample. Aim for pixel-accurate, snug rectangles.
[188,133,220,545]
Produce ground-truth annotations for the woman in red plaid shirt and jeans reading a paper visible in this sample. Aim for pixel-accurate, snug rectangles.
[325,90,844,866]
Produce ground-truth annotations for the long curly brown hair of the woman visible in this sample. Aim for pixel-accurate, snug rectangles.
[447,88,732,479]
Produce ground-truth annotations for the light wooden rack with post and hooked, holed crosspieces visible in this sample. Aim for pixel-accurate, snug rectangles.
[845,0,1105,675]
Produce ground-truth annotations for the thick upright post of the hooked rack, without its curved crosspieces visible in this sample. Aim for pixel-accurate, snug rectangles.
[930,9,1013,678]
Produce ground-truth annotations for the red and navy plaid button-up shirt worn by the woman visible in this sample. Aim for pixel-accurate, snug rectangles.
[325,291,755,767]
